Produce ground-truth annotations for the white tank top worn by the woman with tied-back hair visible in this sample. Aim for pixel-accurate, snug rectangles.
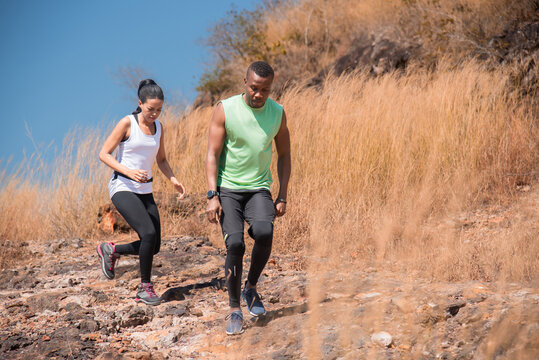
[109,115,161,198]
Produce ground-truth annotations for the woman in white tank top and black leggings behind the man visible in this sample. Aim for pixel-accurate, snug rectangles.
[97,79,185,305]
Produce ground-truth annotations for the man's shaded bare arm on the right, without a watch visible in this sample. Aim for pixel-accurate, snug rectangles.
[275,110,292,216]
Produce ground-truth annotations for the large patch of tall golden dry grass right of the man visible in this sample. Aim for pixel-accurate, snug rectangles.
[278,63,538,279]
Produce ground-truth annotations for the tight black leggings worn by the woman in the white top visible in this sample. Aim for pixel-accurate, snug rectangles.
[112,191,161,283]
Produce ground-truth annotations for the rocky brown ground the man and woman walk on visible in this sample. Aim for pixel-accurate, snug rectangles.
[0,193,539,359]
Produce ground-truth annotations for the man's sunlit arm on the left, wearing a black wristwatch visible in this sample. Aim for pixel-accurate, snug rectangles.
[206,103,226,223]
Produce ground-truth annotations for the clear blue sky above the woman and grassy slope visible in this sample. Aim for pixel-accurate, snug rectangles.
[0,0,258,168]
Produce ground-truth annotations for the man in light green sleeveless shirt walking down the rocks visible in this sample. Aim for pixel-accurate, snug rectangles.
[206,61,291,335]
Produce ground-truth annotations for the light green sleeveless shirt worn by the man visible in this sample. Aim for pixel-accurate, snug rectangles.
[217,94,283,190]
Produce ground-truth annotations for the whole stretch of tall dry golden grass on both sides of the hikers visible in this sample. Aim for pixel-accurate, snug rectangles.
[0,62,539,280]
